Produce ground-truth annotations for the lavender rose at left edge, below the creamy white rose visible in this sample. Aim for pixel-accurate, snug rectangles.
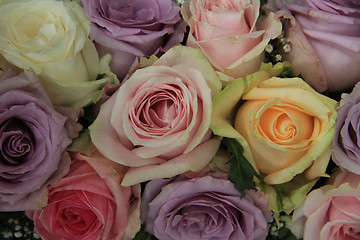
[0,70,77,211]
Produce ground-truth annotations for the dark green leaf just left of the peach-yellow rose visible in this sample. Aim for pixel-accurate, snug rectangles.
[222,138,260,197]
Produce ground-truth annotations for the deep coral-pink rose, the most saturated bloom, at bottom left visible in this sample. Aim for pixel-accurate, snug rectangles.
[27,152,140,240]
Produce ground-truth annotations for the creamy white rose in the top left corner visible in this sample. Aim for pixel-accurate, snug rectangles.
[0,0,116,108]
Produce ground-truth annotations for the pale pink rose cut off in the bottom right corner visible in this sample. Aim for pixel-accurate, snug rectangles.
[293,172,360,240]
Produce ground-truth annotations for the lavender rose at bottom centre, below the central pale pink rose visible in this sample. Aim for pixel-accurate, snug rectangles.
[141,176,272,240]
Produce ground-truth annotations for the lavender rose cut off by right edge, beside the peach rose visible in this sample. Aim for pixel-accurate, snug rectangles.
[332,84,360,174]
